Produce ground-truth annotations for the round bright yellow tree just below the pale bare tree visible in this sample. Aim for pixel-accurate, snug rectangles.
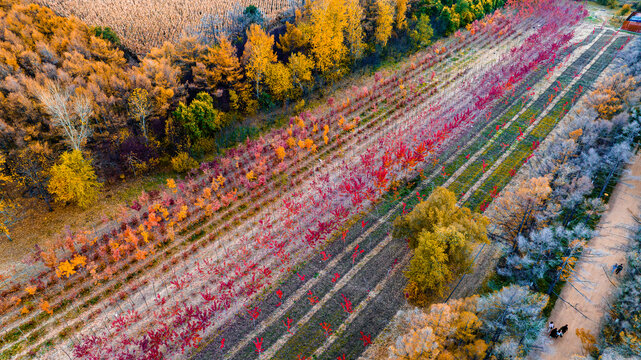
[48,150,102,208]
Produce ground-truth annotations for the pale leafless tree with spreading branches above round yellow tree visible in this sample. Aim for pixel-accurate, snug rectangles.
[36,81,93,150]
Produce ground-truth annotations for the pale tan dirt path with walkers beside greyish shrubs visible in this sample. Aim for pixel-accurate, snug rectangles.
[534,154,641,359]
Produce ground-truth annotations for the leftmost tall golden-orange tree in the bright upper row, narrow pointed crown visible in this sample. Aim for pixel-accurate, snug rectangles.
[243,24,277,96]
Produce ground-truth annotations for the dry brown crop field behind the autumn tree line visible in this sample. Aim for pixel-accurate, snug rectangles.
[34,0,291,55]
